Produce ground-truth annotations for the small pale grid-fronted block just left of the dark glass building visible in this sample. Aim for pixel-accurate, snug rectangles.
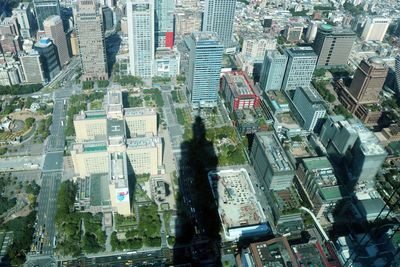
[19,51,44,84]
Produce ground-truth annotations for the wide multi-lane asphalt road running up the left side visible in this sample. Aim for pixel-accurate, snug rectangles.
[26,76,74,266]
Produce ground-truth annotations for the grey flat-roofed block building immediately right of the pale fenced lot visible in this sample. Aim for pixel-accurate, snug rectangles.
[250,132,294,191]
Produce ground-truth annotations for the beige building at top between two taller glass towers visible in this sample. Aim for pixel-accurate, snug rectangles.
[175,9,202,38]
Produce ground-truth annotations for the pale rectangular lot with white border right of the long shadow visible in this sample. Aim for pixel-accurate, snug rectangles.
[208,169,270,241]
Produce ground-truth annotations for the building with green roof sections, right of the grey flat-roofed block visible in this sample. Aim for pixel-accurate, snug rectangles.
[296,157,346,218]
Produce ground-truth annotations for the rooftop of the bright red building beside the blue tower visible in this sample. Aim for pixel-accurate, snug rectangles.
[224,71,254,97]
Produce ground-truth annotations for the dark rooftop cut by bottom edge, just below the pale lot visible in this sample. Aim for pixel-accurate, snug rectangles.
[250,237,298,267]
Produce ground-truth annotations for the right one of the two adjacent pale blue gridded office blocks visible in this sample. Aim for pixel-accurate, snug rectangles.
[282,46,318,90]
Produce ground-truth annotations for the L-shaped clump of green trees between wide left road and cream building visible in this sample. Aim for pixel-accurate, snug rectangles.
[55,181,106,256]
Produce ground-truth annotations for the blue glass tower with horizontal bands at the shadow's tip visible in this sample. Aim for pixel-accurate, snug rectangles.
[187,32,224,108]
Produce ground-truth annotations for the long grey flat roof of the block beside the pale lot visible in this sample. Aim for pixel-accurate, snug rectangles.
[256,132,293,173]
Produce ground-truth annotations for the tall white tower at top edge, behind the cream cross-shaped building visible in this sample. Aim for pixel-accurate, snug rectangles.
[127,0,155,79]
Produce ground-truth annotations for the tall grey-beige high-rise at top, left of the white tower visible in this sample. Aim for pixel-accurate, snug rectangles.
[76,0,108,80]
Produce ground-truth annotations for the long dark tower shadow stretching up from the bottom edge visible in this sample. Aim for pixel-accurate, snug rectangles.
[172,117,221,266]
